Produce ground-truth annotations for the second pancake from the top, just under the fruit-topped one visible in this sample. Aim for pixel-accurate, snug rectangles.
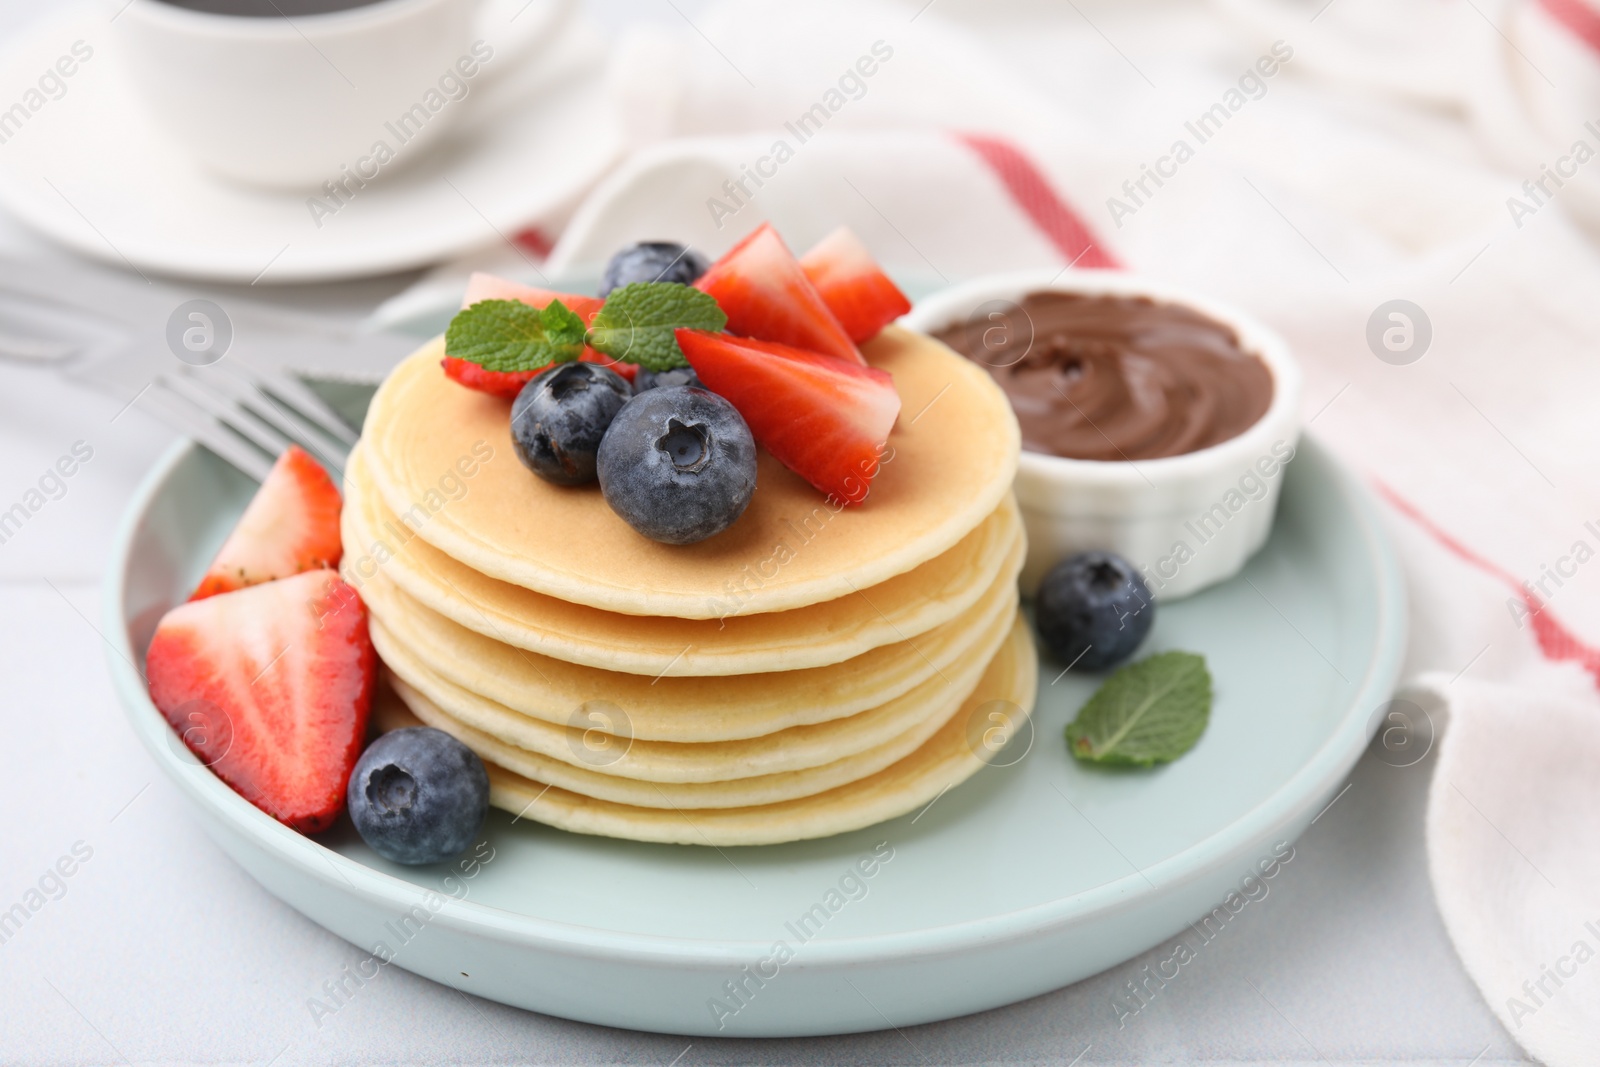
[339,446,1022,678]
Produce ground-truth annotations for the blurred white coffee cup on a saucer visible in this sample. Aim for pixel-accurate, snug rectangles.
[115,0,568,189]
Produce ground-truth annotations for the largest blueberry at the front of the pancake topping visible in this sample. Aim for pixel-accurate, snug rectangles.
[598,386,755,544]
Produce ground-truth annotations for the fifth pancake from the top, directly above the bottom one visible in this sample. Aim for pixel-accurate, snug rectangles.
[389,677,965,809]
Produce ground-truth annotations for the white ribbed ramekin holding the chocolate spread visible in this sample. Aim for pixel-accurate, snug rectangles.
[901,270,1301,600]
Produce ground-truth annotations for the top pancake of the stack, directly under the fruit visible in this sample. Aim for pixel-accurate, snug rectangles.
[363,326,1021,619]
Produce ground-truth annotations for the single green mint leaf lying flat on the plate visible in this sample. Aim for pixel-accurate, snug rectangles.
[1067,653,1211,766]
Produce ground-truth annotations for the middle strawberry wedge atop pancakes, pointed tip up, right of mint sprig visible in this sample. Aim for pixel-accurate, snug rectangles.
[694,222,866,365]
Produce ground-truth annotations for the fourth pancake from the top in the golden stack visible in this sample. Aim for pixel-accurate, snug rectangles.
[371,593,1016,780]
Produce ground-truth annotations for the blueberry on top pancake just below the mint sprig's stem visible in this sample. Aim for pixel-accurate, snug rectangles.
[510,363,634,485]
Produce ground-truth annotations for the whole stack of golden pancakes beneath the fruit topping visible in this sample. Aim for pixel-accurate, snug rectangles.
[342,330,1037,846]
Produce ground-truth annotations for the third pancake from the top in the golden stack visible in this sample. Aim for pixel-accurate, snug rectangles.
[362,544,1022,742]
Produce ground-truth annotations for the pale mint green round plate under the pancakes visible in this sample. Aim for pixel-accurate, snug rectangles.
[104,415,1405,1037]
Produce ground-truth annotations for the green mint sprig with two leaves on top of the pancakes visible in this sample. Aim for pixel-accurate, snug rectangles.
[445,282,728,371]
